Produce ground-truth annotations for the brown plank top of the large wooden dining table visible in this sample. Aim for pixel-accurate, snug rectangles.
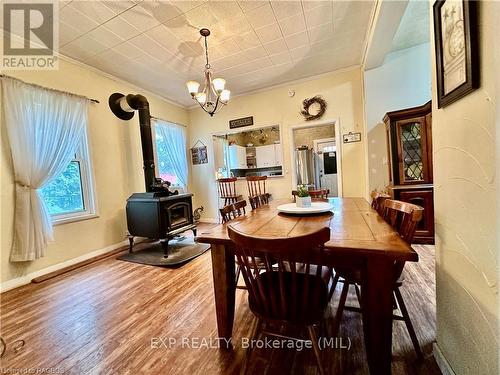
[196,198,418,261]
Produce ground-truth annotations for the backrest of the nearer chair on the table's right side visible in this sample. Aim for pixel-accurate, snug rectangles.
[382,199,424,244]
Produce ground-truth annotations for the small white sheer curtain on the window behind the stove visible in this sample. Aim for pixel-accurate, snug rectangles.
[154,119,188,188]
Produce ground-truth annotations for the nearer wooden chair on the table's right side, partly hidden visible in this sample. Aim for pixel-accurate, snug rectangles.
[329,198,424,360]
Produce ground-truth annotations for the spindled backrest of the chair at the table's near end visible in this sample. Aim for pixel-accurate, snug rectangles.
[228,224,330,320]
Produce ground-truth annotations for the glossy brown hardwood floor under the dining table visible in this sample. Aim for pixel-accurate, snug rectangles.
[0,225,440,375]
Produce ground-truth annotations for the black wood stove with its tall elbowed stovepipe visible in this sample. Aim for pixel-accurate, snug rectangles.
[109,93,196,257]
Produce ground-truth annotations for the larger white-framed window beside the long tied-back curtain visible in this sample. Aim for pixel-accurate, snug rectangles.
[40,130,95,224]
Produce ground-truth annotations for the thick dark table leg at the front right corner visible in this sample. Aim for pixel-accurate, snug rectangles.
[361,257,394,375]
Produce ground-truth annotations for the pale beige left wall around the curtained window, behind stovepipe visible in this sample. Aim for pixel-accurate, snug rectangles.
[0,60,188,282]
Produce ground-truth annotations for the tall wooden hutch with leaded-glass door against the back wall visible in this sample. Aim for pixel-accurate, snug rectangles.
[384,101,434,244]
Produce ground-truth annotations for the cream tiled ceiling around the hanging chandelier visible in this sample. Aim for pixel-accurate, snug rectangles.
[6,0,374,106]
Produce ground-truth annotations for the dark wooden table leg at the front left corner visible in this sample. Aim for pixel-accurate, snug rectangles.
[211,244,236,346]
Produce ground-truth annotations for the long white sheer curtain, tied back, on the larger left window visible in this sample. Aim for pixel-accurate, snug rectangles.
[2,77,89,262]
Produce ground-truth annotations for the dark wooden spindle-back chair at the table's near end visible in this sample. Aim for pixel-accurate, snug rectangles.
[228,225,330,374]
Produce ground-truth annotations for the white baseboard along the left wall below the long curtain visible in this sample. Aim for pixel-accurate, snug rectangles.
[0,240,136,293]
